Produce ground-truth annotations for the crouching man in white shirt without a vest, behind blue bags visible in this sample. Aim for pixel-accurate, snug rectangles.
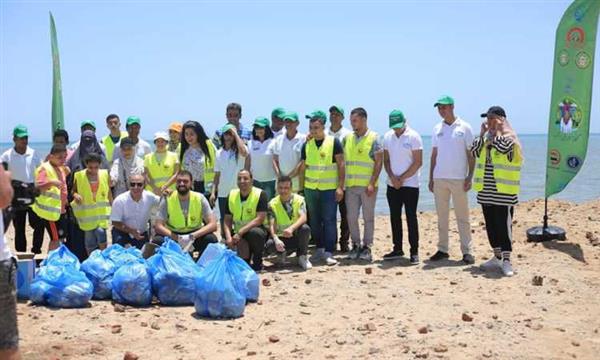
[110,173,160,249]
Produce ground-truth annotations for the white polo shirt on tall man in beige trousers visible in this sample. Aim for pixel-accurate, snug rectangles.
[431,117,473,180]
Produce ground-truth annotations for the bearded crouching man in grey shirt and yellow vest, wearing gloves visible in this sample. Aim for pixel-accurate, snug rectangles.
[152,170,218,256]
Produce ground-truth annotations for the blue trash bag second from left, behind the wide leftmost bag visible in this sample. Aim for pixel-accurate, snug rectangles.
[81,250,116,300]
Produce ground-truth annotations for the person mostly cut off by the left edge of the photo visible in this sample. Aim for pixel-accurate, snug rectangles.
[0,166,21,360]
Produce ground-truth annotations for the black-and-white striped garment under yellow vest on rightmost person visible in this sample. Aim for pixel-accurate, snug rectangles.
[471,136,519,206]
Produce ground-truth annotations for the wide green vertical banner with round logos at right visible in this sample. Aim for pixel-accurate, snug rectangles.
[546,0,600,198]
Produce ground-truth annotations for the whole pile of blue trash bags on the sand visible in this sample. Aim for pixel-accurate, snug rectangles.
[30,239,260,318]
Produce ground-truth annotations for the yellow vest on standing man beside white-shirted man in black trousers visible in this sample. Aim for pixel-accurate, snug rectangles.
[344,130,377,187]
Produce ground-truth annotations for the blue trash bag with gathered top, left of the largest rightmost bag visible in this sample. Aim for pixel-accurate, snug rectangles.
[147,244,201,306]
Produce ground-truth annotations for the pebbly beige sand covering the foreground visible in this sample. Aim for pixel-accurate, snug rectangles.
[8,200,600,359]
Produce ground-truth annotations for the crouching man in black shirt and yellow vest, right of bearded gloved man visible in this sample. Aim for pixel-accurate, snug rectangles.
[223,170,268,271]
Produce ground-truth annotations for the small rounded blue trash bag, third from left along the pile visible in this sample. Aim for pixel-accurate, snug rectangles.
[112,259,152,306]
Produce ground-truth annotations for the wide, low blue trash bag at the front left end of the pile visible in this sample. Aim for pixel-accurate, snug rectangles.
[29,260,94,308]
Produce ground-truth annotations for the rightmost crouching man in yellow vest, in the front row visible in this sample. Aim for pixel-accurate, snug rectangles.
[266,176,312,270]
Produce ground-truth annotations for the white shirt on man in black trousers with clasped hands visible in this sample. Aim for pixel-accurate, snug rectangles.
[383,126,423,188]
